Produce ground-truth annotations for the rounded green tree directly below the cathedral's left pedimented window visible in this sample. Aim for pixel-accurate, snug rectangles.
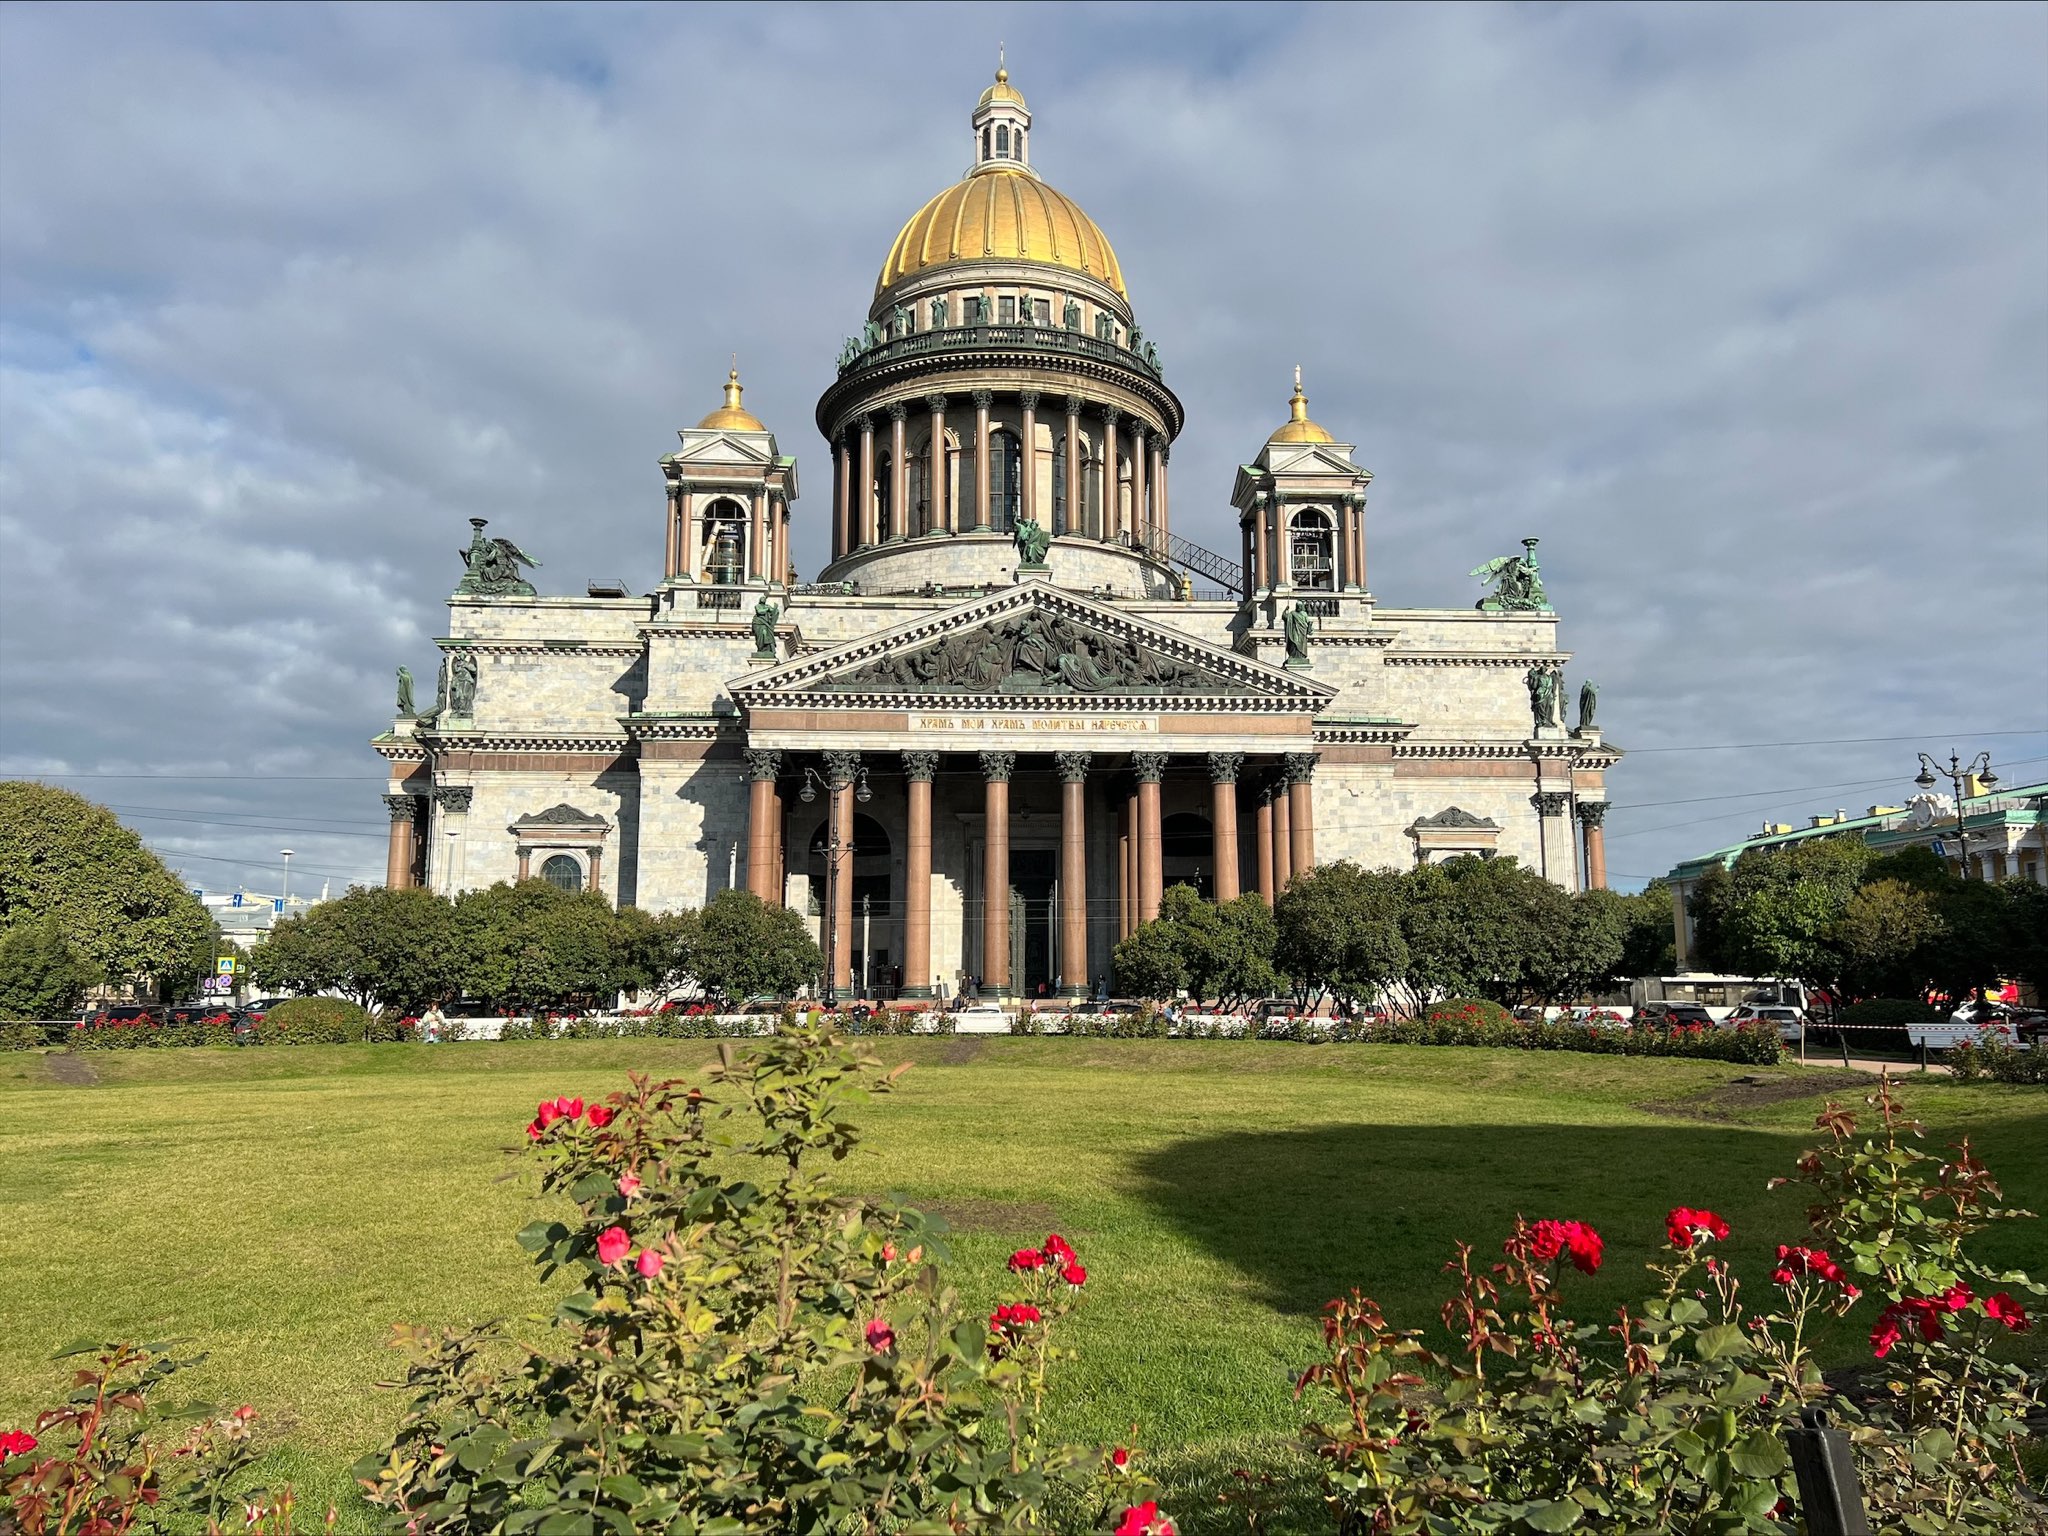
[453,881,623,1012]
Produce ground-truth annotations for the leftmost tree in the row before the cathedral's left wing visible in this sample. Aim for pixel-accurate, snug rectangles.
[250,885,463,1014]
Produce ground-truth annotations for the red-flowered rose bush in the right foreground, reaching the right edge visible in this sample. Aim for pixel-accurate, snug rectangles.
[1300,1079,2048,1536]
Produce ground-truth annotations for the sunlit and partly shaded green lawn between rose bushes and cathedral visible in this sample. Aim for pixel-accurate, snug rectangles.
[0,1038,2048,1531]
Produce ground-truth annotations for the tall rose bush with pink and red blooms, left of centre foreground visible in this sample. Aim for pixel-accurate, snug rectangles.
[356,1018,1171,1536]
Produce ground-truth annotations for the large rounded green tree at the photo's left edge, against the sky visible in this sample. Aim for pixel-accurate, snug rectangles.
[0,780,213,995]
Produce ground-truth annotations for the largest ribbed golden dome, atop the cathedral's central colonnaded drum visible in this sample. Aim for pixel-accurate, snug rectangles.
[874,167,1128,297]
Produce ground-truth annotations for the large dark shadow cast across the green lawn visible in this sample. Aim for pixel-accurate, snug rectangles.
[1137,1124,1810,1325]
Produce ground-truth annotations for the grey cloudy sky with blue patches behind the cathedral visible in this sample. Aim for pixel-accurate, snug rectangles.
[0,2,2048,889]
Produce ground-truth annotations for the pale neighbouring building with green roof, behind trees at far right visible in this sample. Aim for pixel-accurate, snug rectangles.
[1665,778,2048,971]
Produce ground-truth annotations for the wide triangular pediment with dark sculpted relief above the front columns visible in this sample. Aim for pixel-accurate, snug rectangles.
[733,582,1335,715]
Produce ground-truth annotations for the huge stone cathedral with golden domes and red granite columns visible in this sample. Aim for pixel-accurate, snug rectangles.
[375,72,1620,997]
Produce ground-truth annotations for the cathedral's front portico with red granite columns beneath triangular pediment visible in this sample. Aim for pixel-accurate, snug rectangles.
[735,582,1331,997]
